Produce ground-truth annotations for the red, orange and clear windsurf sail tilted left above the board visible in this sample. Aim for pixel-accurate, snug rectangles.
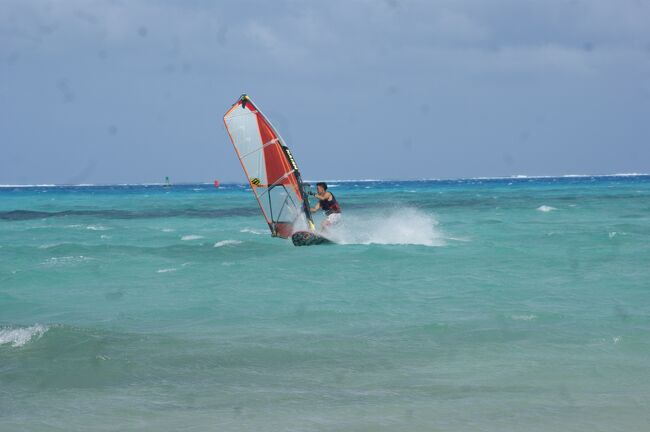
[223,95,314,238]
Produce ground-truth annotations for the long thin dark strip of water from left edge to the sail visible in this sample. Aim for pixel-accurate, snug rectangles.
[0,206,259,221]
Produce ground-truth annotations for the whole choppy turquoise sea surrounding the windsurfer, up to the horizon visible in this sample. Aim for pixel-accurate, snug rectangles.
[0,176,650,431]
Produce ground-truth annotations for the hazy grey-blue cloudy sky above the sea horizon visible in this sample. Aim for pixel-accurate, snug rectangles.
[0,0,650,184]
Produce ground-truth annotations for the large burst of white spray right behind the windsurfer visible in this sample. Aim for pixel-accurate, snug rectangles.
[326,208,445,246]
